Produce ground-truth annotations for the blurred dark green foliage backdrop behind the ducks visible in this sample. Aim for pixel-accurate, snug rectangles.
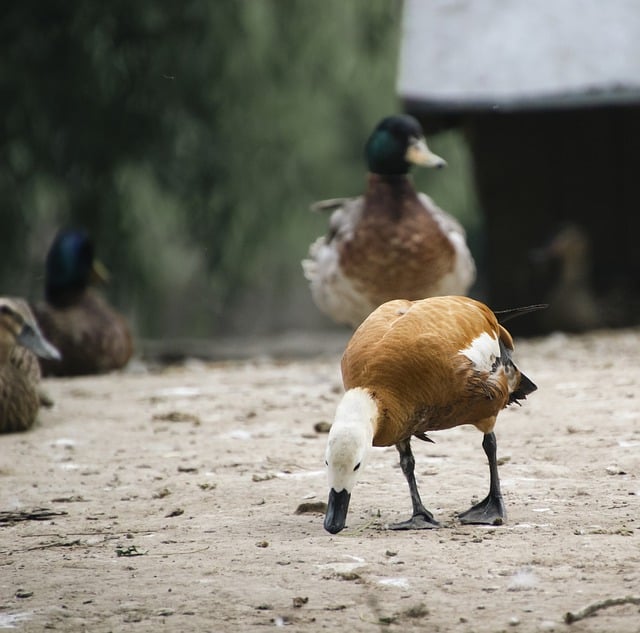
[0,0,480,337]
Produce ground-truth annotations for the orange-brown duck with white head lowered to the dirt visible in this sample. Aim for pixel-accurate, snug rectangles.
[324,296,537,534]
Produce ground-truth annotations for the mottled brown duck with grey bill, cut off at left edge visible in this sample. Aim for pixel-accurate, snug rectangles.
[0,297,60,433]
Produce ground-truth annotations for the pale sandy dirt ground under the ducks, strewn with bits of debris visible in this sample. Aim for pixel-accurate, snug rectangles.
[0,330,640,633]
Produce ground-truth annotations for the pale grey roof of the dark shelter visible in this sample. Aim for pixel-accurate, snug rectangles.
[398,0,640,111]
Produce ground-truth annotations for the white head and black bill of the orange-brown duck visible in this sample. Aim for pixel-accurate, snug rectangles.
[324,388,378,534]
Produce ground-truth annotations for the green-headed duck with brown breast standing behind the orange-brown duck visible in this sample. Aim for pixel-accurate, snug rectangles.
[302,115,476,327]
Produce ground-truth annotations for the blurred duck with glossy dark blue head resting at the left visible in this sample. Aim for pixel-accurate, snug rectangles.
[33,230,133,376]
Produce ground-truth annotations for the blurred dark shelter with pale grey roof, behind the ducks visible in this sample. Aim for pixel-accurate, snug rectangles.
[398,0,640,334]
